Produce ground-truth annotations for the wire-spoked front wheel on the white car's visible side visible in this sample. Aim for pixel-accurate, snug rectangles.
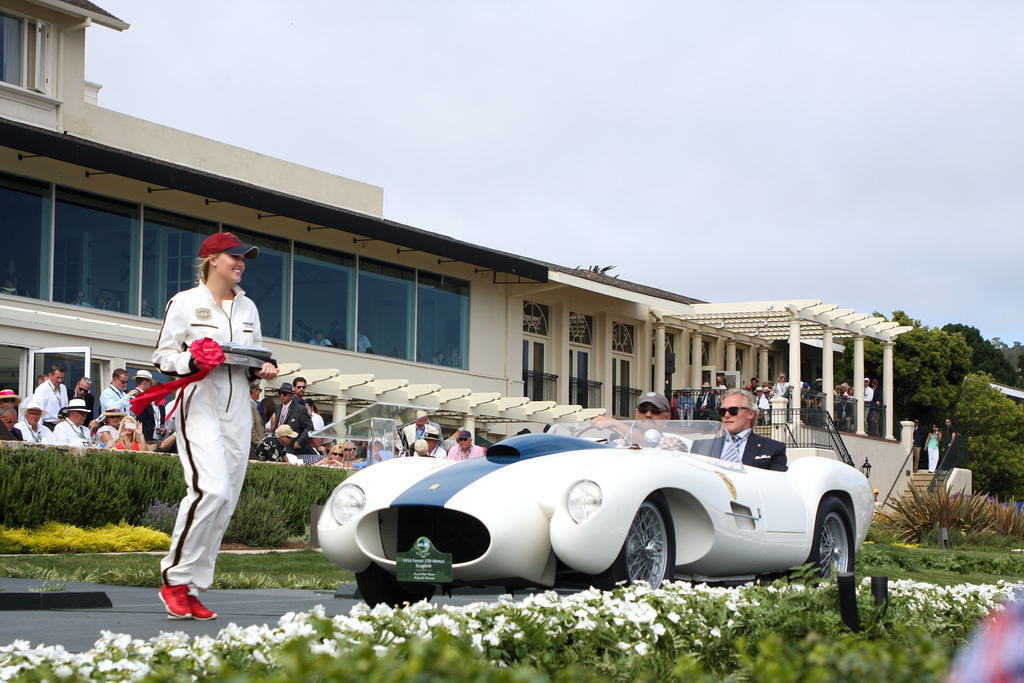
[594,493,676,590]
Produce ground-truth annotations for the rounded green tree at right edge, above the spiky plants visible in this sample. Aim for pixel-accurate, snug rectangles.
[953,374,1024,501]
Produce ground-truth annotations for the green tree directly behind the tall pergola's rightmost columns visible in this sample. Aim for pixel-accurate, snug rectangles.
[836,310,971,423]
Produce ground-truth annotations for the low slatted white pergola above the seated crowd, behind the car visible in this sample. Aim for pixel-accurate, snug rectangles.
[266,362,605,434]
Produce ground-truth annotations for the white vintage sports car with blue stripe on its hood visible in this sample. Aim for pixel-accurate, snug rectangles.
[317,421,874,604]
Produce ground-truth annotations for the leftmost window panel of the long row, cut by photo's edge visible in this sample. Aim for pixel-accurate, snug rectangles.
[0,169,50,299]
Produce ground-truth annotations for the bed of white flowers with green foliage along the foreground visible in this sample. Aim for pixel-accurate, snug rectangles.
[0,579,1024,681]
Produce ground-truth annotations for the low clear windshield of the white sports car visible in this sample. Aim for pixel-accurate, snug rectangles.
[549,419,725,455]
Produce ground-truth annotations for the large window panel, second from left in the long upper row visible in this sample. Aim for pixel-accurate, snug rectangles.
[53,188,139,312]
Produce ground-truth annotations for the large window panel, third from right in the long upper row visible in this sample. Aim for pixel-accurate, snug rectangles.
[292,245,355,348]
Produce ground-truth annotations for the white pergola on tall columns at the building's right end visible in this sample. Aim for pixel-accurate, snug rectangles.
[654,299,912,438]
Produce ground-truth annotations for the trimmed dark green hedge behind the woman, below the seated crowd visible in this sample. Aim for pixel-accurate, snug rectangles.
[0,446,347,536]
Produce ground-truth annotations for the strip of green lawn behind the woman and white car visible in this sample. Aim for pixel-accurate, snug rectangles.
[0,544,1024,590]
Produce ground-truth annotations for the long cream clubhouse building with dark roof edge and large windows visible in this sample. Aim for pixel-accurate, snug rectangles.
[0,0,902,448]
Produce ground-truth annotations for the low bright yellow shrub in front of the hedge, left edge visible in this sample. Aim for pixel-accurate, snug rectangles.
[0,522,171,553]
